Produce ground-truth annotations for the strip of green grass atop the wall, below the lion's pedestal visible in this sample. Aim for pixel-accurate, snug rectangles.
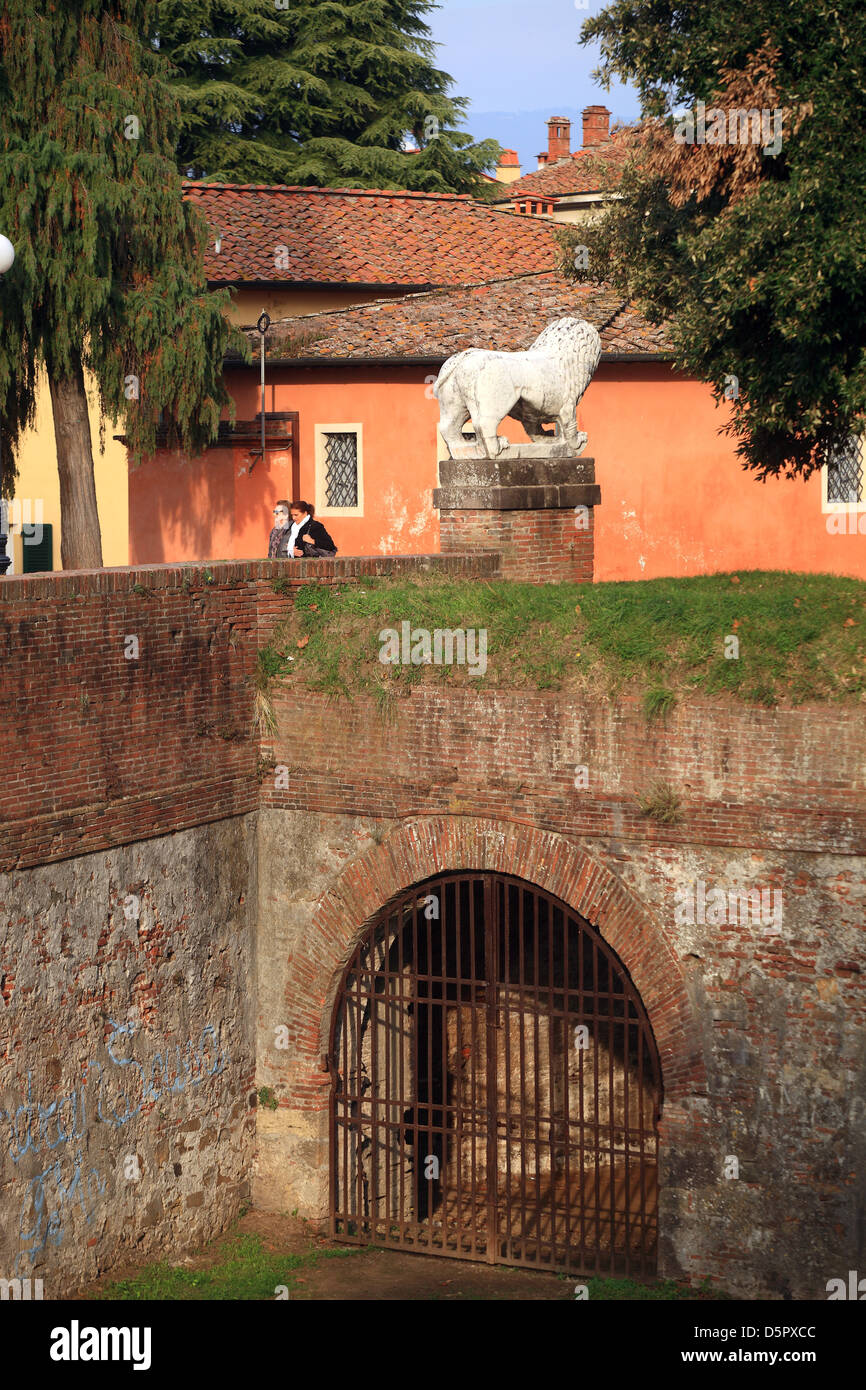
[261,570,866,719]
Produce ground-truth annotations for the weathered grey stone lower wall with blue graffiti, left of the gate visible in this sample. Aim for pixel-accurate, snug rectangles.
[0,815,256,1298]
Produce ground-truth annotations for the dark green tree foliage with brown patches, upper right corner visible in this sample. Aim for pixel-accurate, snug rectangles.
[564,0,866,478]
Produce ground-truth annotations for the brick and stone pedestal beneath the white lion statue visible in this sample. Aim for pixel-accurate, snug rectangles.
[434,445,601,584]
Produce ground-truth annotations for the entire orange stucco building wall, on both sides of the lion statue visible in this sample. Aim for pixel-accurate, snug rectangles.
[129,363,866,580]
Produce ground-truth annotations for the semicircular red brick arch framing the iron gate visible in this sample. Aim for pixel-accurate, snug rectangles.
[286,816,706,1118]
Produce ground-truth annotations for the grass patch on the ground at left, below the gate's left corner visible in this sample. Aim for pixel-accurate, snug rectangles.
[96,1236,360,1302]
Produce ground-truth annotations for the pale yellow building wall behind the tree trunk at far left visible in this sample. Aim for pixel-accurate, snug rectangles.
[7,366,129,573]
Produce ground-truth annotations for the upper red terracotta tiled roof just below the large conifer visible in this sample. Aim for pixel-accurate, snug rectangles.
[183,182,556,285]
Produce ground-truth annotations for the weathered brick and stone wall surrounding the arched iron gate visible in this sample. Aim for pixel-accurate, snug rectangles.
[253,685,866,1298]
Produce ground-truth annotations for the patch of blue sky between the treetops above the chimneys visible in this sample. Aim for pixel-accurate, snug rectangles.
[427,0,638,174]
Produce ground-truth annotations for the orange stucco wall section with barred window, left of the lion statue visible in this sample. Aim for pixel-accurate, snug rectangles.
[129,368,439,564]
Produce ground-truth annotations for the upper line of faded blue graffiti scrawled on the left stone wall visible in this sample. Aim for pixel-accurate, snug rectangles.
[0,1019,229,1163]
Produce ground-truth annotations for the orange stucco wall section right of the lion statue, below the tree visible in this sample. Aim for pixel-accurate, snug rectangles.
[580,364,866,580]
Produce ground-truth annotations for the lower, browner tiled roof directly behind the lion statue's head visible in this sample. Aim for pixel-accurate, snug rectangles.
[232,271,670,363]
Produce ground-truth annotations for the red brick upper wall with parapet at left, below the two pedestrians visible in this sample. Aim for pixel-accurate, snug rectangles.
[0,556,498,869]
